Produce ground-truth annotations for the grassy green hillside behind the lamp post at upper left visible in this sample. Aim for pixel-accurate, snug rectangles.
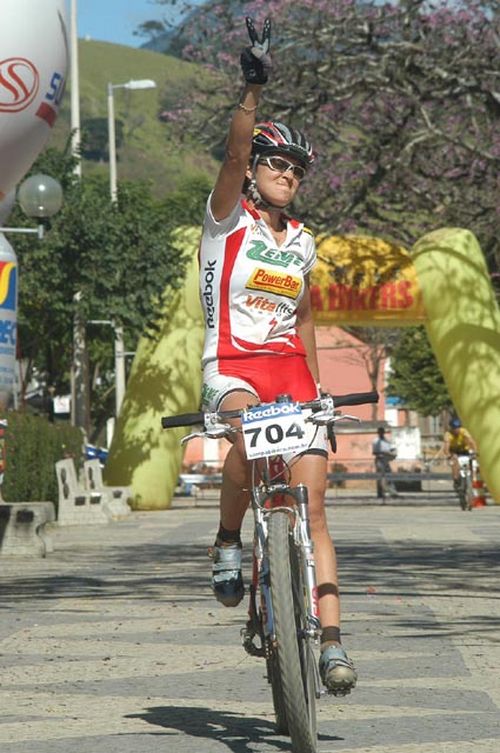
[48,40,216,195]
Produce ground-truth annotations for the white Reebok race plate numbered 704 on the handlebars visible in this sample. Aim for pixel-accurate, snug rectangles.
[242,403,308,460]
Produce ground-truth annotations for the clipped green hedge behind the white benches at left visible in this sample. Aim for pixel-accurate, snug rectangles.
[2,411,83,506]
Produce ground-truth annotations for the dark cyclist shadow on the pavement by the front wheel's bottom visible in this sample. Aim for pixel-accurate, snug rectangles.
[126,706,342,753]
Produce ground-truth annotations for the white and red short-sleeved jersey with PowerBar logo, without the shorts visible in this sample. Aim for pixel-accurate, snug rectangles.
[200,196,316,366]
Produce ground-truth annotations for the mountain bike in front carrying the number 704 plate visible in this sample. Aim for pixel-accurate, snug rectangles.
[162,392,378,753]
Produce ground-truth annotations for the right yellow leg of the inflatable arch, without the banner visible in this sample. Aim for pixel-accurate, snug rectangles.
[412,228,500,503]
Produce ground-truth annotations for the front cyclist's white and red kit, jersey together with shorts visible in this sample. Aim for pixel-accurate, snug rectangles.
[200,197,328,456]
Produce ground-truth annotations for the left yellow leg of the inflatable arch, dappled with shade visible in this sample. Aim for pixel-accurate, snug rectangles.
[104,227,205,510]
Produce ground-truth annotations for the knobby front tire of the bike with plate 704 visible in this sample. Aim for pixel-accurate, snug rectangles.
[268,512,317,753]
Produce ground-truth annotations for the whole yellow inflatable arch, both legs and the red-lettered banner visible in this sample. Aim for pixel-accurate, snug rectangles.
[106,228,500,509]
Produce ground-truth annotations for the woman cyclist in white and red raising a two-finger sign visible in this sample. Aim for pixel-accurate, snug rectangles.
[200,14,356,694]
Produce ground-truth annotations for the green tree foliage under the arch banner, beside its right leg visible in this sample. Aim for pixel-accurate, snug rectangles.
[387,327,452,416]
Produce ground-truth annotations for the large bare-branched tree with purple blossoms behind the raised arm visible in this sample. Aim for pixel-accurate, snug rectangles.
[144,0,500,273]
